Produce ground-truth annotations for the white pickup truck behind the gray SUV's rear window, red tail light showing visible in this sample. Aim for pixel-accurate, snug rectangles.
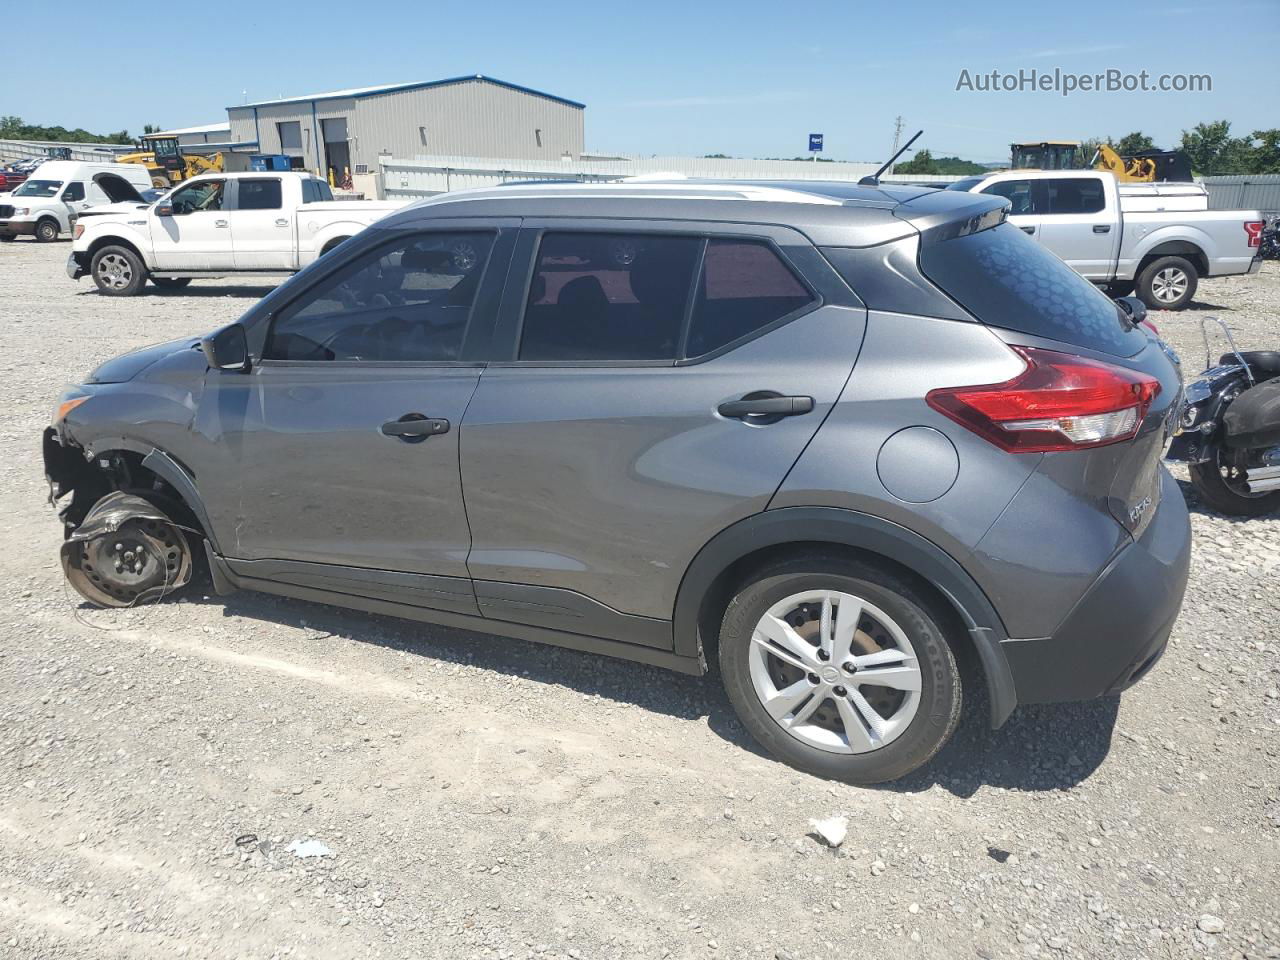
[947,170,1265,310]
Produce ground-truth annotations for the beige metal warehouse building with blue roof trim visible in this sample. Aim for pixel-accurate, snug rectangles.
[227,74,584,177]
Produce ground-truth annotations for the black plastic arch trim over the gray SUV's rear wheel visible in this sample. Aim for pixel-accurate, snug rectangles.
[672,507,1018,727]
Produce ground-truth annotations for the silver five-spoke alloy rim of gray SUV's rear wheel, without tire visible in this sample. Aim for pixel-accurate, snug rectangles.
[749,590,923,754]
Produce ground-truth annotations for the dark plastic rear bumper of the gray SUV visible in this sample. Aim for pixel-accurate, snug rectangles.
[1001,468,1192,703]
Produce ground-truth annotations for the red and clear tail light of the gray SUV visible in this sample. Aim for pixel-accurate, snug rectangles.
[924,347,1160,453]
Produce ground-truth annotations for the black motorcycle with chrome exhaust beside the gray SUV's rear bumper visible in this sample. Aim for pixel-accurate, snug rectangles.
[1165,317,1280,517]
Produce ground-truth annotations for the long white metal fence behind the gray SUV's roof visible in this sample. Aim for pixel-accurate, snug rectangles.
[378,156,959,200]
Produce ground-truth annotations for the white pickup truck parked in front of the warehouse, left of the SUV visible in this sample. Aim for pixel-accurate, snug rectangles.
[67,173,403,297]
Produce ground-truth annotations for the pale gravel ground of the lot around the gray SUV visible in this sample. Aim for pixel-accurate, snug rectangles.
[0,242,1280,960]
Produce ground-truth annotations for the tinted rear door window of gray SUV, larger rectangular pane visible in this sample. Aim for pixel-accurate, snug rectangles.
[520,233,703,361]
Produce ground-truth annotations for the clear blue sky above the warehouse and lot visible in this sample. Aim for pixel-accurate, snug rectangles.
[12,0,1280,160]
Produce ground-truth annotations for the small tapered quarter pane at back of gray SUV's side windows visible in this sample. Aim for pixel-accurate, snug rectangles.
[685,239,813,357]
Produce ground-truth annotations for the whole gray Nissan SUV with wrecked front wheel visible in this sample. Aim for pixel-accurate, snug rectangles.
[45,180,1190,783]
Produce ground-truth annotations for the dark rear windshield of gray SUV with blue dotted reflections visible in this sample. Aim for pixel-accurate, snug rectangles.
[920,224,1147,357]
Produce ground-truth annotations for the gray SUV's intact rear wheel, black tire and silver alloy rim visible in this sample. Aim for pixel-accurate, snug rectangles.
[719,556,960,783]
